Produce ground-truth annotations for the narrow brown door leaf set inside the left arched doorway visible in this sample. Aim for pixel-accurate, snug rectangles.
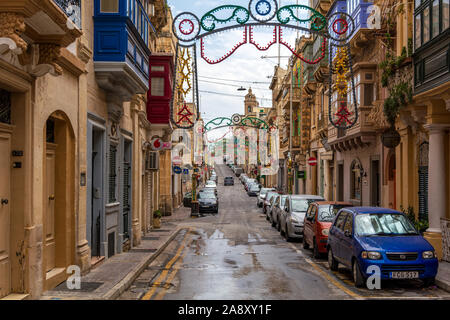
[44,143,56,272]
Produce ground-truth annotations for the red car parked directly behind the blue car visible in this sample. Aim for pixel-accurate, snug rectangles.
[303,201,353,258]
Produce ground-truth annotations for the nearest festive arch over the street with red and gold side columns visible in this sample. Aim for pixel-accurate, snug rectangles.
[172,0,358,131]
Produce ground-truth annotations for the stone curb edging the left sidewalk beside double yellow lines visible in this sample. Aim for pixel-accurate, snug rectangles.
[101,228,183,300]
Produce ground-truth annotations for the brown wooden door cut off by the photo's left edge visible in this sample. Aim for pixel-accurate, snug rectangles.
[0,127,11,298]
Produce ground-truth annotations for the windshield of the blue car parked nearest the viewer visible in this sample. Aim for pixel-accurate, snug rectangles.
[355,213,417,237]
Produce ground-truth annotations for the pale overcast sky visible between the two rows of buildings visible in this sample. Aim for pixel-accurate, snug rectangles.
[168,0,308,134]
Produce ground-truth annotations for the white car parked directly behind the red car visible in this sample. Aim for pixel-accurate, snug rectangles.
[280,195,325,241]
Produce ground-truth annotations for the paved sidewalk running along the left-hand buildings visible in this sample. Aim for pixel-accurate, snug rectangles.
[40,207,190,300]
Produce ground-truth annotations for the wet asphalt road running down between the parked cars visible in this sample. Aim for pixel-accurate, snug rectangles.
[119,166,450,300]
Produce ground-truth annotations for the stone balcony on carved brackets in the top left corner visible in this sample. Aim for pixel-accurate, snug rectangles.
[0,0,82,77]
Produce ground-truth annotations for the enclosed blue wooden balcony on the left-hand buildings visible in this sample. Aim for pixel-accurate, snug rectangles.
[94,0,155,101]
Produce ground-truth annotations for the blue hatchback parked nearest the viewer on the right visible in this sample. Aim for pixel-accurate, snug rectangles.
[327,207,438,287]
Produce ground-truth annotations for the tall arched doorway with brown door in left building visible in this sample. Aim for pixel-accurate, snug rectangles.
[42,111,75,290]
